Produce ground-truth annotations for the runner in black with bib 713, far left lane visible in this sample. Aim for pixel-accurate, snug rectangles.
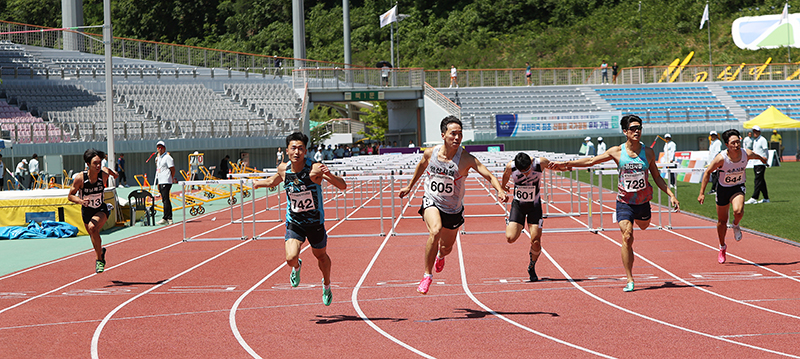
[67,149,118,273]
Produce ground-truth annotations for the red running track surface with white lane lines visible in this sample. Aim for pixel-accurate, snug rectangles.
[0,179,800,358]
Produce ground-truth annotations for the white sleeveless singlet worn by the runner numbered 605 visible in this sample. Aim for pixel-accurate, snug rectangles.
[422,145,466,214]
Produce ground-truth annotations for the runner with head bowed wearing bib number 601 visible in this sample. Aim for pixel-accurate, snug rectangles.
[500,152,550,282]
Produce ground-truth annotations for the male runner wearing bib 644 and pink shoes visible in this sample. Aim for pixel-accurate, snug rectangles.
[697,129,767,264]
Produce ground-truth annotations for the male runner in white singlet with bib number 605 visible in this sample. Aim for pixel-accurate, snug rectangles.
[399,116,506,294]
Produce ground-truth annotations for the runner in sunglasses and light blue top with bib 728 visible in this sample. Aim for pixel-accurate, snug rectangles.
[548,115,680,292]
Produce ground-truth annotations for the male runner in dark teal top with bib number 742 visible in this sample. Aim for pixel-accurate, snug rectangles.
[253,132,347,305]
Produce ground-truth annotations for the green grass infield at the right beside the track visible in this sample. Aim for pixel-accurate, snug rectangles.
[579,162,800,242]
